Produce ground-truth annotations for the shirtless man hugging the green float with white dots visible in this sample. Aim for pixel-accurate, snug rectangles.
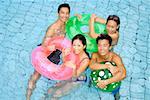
[89,34,126,99]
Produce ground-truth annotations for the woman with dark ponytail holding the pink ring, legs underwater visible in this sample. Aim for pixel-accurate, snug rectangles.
[48,34,90,99]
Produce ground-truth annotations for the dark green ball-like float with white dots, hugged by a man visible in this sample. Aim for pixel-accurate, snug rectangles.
[90,61,121,92]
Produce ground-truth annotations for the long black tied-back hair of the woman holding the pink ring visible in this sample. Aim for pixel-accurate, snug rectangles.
[72,34,90,58]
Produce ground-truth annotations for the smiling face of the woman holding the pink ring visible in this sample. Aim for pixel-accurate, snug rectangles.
[73,39,86,54]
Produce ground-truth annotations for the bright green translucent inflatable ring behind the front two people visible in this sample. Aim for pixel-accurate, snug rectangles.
[66,14,107,53]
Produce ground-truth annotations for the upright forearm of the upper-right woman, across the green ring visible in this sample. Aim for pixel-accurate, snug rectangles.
[89,14,99,39]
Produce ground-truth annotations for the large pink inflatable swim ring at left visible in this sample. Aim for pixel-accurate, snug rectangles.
[31,37,76,80]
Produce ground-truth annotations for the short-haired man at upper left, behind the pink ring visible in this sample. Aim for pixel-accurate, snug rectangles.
[26,3,70,100]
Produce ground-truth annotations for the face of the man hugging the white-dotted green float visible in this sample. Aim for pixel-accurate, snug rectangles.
[98,39,110,56]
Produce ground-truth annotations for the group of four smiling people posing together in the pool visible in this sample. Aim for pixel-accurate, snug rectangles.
[26,3,126,100]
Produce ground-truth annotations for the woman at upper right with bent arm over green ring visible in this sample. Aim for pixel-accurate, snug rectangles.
[89,14,120,46]
